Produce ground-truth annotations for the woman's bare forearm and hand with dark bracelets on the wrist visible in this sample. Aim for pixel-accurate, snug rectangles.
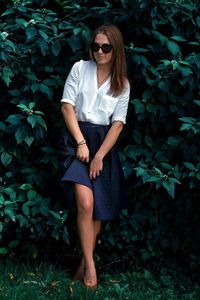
[61,103,89,162]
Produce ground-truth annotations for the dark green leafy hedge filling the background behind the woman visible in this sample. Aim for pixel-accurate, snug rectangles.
[0,0,200,268]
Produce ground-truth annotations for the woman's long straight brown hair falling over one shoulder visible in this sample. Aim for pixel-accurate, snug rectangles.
[90,24,128,96]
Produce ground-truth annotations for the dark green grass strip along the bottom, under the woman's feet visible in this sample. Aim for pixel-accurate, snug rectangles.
[0,255,200,300]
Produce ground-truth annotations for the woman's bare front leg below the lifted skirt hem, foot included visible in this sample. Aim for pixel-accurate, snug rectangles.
[75,184,101,287]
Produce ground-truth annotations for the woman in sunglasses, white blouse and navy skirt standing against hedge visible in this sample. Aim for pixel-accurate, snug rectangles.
[61,25,130,288]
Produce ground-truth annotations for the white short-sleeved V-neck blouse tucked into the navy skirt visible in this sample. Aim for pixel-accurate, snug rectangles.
[61,60,130,125]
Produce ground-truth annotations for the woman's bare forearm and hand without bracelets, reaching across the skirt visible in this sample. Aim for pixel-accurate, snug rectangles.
[89,121,123,179]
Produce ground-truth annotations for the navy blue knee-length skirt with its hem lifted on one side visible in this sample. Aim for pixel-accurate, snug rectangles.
[59,122,127,220]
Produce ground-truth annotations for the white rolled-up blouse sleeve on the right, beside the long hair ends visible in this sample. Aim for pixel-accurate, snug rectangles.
[111,83,130,124]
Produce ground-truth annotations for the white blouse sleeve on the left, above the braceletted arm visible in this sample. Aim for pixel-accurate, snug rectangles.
[61,60,83,106]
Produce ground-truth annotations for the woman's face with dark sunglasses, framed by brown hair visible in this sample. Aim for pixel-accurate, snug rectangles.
[92,33,113,65]
